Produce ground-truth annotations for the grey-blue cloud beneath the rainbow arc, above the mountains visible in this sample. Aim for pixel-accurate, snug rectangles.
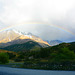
[14,24,75,42]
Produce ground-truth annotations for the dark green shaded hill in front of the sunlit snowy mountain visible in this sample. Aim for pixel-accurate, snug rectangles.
[2,41,42,52]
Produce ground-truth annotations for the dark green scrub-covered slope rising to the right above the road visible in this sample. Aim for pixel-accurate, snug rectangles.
[0,43,75,70]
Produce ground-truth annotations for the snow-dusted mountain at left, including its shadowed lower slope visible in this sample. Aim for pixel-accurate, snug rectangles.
[0,30,50,47]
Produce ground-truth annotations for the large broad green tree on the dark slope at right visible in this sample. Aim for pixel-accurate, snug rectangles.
[50,47,75,62]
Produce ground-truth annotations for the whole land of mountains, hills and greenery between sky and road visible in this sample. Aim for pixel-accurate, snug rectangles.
[0,30,75,71]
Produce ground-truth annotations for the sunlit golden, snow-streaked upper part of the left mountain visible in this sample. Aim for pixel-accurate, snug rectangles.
[0,29,49,46]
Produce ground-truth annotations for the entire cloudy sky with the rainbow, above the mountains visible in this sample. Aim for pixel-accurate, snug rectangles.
[0,0,75,42]
